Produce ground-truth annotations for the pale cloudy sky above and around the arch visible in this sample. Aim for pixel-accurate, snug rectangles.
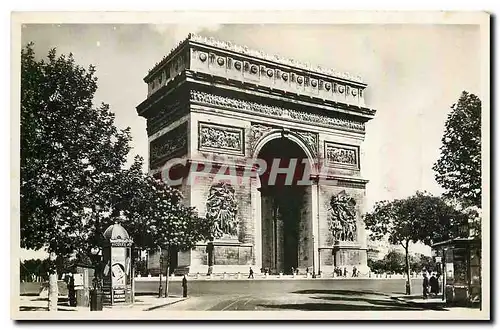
[21,24,481,260]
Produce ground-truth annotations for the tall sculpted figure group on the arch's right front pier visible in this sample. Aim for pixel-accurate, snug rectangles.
[329,190,357,242]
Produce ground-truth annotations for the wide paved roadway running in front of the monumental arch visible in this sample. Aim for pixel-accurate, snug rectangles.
[138,279,438,311]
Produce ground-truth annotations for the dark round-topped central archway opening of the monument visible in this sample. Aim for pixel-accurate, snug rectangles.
[258,137,312,274]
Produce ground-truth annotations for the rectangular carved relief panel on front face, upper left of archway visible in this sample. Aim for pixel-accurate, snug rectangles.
[198,123,244,154]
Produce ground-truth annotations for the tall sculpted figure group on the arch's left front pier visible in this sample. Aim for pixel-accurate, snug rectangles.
[206,182,239,239]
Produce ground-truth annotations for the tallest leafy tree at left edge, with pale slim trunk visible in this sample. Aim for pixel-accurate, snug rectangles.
[20,43,134,310]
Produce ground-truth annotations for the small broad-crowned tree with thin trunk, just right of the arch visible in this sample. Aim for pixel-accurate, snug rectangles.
[364,192,466,294]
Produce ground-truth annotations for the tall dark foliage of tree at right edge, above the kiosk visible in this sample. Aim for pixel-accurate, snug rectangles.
[433,91,481,208]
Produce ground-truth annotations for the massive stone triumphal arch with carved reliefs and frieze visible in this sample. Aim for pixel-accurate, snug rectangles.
[137,35,375,274]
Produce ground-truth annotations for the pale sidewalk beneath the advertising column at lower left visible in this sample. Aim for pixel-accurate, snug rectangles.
[19,295,188,312]
